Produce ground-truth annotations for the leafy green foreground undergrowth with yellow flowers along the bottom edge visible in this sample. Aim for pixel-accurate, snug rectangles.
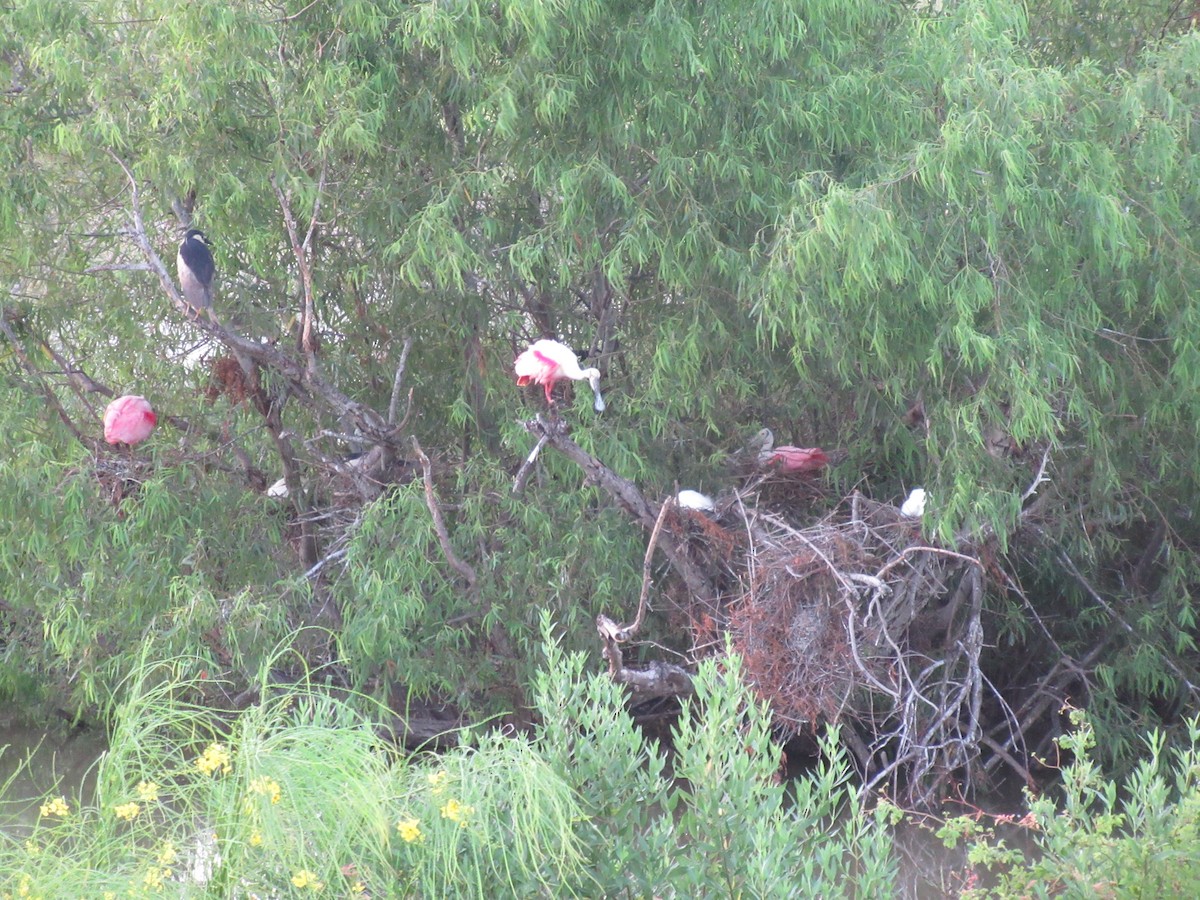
[0,618,1200,898]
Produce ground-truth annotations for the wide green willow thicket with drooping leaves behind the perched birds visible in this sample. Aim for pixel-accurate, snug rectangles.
[0,0,1200,787]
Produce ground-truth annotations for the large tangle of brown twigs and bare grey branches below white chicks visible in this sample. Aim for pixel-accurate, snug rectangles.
[728,494,983,803]
